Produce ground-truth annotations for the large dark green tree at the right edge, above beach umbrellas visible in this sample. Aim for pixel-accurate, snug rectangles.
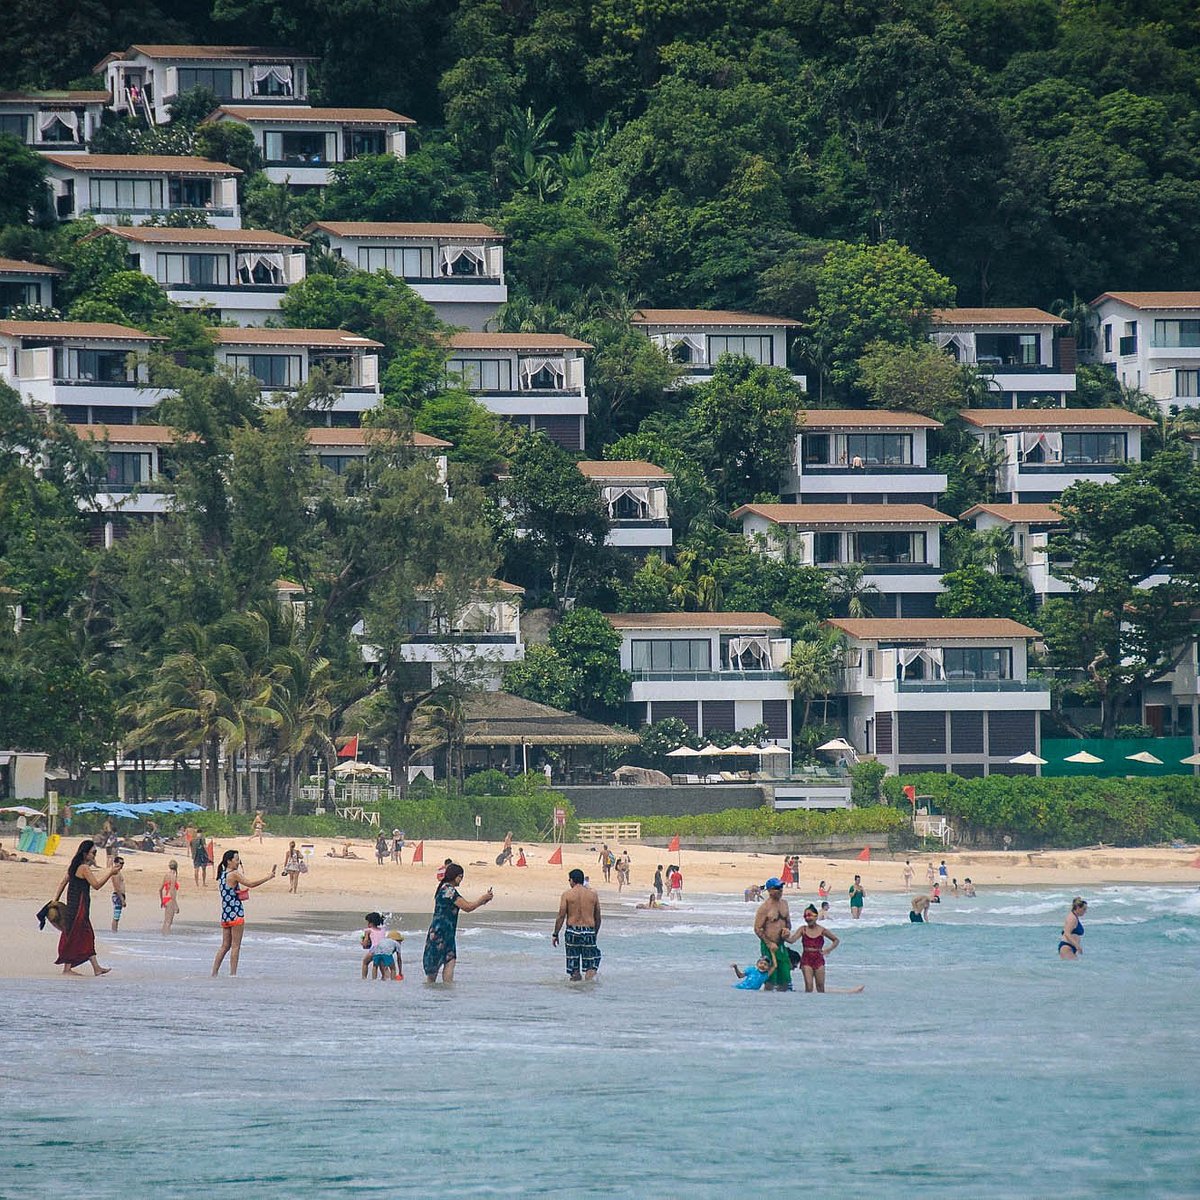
[1038,449,1200,737]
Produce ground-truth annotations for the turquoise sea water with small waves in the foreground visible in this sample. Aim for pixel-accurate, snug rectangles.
[0,887,1200,1200]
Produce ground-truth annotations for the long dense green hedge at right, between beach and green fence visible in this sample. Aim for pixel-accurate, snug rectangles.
[883,773,1200,848]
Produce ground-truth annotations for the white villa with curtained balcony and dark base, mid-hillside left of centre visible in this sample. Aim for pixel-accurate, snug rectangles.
[448,334,592,450]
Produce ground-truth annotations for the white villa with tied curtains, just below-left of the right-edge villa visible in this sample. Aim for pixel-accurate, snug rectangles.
[961,408,1154,503]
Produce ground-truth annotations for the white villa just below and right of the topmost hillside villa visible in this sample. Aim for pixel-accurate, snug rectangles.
[210,104,416,186]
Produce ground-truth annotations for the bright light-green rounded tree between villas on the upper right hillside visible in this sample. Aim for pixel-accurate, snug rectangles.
[806,241,954,394]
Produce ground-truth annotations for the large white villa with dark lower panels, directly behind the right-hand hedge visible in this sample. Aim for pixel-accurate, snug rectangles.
[829,618,1050,775]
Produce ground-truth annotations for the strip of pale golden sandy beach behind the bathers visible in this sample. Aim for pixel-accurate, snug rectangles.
[0,836,1200,978]
